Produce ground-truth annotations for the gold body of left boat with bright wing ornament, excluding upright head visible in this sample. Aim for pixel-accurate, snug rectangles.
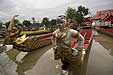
[13,33,52,51]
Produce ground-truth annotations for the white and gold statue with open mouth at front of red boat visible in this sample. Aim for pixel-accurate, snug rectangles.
[52,14,85,74]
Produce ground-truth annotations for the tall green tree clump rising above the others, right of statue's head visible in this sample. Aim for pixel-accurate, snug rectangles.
[66,6,89,24]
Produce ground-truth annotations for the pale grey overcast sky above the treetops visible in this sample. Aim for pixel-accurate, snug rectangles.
[0,0,113,22]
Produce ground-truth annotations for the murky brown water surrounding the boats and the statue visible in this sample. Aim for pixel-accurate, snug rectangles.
[0,32,113,75]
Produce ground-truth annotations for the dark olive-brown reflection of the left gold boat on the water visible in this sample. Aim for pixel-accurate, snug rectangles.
[16,45,52,75]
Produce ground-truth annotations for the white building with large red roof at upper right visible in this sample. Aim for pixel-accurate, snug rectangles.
[90,9,113,26]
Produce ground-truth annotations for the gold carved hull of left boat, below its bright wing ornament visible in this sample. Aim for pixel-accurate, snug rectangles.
[13,33,52,52]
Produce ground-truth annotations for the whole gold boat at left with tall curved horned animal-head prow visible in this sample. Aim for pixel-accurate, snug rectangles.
[4,15,52,51]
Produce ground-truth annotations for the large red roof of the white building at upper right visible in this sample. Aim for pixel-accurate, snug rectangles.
[91,9,113,20]
